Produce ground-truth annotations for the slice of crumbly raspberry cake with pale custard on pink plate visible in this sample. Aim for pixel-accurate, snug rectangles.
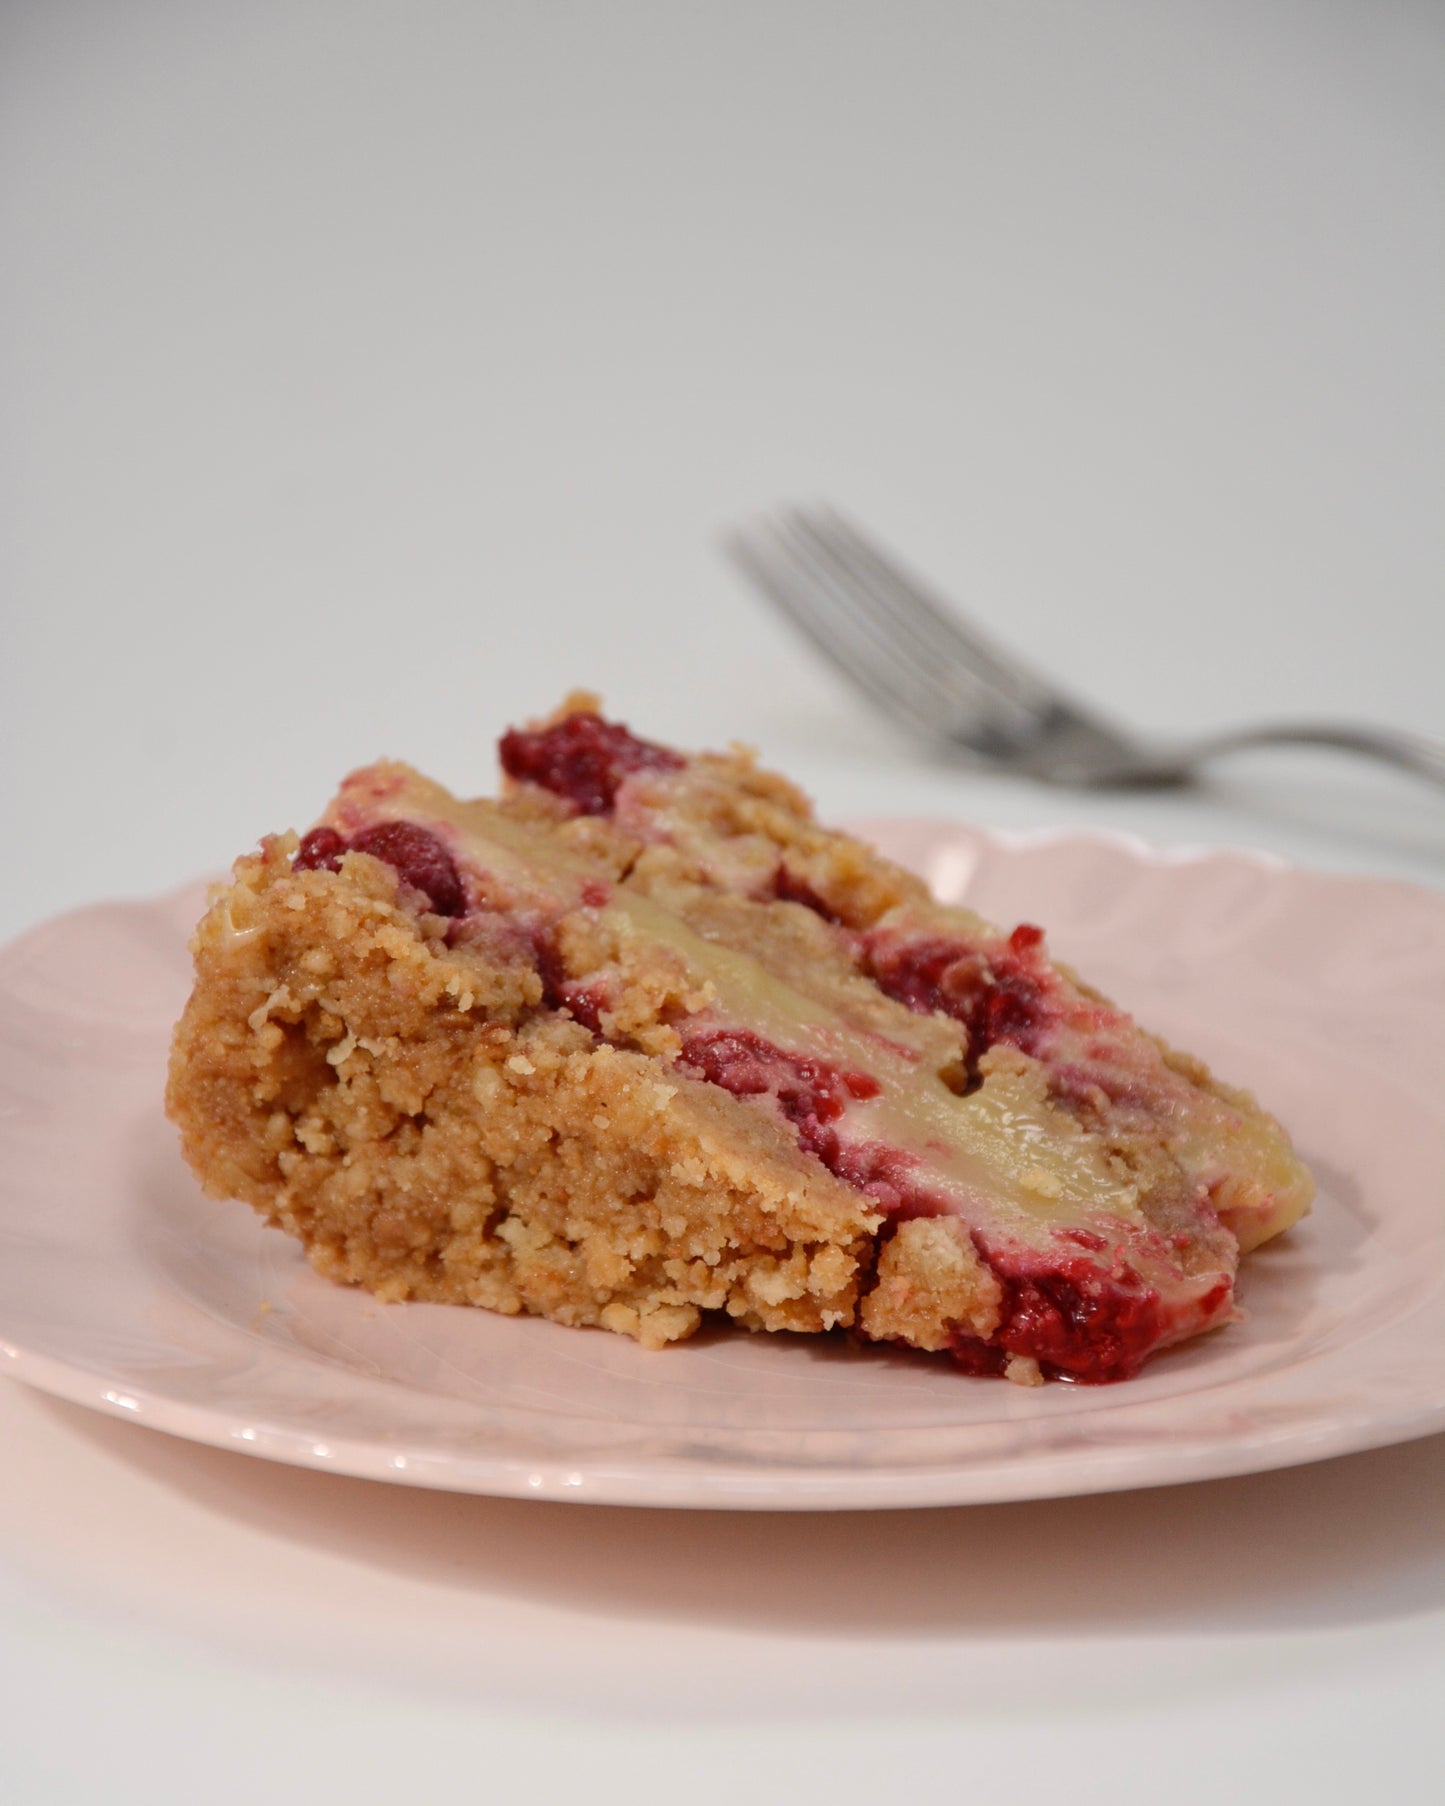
[168,697,1311,1382]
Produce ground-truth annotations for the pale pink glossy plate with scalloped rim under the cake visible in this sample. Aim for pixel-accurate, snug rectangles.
[0,822,1445,1508]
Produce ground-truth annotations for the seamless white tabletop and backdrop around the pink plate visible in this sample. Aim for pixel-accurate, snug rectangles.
[0,0,1445,1806]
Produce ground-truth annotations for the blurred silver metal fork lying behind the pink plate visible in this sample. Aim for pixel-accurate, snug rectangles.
[726,507,1445,786]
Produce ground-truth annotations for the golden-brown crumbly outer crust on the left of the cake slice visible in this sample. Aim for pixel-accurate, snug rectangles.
[166,836,1004,1350]
